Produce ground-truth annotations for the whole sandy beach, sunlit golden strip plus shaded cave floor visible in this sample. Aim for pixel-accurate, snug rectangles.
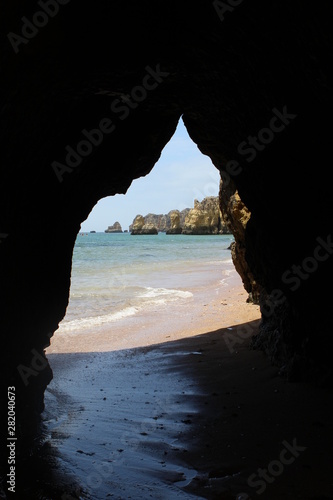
[21,273,333,500]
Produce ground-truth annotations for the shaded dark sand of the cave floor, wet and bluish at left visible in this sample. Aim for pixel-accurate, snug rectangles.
[40,330,333,500]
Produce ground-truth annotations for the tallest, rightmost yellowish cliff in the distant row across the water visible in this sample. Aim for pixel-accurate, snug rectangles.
[182,196,230,234]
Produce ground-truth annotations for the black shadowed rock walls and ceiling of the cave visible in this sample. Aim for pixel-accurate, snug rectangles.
[0,0,333,496]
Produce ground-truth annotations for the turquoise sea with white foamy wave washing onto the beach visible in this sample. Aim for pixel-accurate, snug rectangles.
[60,233,233,333]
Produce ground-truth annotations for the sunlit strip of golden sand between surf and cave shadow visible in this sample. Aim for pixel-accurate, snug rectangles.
[46,269,260,356]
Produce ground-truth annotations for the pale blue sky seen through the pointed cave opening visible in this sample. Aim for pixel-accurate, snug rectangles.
[81,119,220,232]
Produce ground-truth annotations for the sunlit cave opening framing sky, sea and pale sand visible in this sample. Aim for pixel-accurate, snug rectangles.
[47,120,252,353]
